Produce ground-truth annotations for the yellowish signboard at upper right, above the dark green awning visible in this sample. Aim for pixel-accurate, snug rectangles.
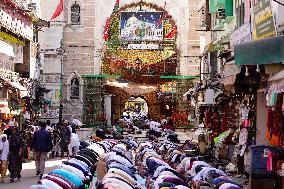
[253,0,276,40]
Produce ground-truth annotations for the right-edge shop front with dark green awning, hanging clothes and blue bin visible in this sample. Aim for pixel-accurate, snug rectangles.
[234,36,284,188]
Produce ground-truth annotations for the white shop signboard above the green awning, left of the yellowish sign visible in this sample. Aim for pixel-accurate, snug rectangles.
[230,22,251,49]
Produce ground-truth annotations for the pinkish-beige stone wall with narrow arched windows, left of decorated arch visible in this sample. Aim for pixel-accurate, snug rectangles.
[63,0,96,120]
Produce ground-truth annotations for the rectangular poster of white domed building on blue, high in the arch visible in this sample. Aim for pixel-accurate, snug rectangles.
[120,12,163,41]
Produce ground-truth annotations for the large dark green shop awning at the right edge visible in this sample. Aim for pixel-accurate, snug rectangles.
[234,36,284,65]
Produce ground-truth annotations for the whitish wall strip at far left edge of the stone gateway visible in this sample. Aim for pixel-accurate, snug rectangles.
[38,0,65,123]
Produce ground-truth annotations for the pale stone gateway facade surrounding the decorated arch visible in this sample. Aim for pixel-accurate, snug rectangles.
[39,0,204,125]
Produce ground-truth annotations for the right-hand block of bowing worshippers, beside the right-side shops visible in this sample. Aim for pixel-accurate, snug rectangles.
[136,140,242,189]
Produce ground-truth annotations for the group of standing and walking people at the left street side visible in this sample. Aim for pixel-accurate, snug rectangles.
[0,120,80,183]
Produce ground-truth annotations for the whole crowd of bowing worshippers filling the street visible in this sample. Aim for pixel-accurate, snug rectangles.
[26,117,242,189]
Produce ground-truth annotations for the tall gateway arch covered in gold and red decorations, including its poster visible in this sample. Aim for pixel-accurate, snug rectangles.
[102,1,179,119]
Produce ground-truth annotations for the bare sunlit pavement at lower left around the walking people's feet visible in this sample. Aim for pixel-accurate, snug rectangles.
[0,160,62,189]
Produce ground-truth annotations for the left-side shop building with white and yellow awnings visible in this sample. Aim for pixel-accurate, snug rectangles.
[0,1,38,127]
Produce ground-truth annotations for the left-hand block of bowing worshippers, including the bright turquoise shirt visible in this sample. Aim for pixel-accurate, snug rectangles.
[30,137,140,189]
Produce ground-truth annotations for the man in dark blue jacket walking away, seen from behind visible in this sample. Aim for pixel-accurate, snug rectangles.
[32,122,52,176]
